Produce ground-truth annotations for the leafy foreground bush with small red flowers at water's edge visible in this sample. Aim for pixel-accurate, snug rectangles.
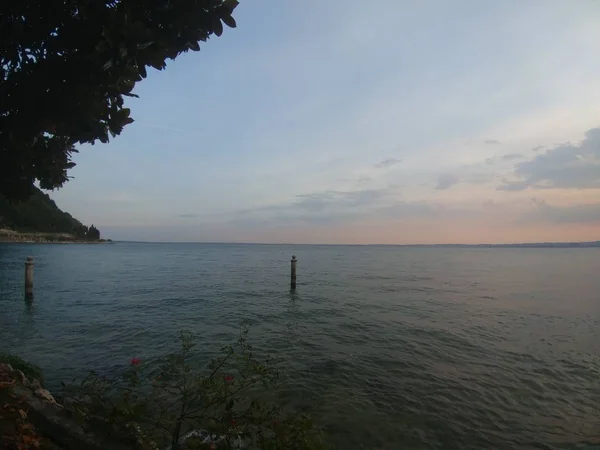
[65,330,324,450]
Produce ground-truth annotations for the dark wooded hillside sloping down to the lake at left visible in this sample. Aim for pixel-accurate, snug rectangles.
[0,188,100,241]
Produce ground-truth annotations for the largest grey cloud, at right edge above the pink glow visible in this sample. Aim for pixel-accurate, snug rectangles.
[498,128,600,191]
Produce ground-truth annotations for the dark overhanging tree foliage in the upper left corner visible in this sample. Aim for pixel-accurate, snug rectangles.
[0,0,238,199]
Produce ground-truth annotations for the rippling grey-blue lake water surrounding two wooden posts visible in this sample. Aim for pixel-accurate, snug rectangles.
[0,243,600,449]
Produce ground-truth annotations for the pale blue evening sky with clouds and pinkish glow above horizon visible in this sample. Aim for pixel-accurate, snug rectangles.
[51,0,600,244]
